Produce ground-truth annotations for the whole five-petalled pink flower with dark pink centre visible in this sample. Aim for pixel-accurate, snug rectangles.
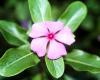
[29,21,75,59]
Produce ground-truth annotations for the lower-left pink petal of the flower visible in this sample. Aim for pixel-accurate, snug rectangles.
[31,37,48,57]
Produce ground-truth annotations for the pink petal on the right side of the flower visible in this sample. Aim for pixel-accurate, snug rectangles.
[55,27,75,45]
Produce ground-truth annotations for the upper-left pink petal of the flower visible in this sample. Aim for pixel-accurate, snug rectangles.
[29,22,48,38]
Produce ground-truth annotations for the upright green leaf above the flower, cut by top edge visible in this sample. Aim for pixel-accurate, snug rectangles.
[28,0,51,22]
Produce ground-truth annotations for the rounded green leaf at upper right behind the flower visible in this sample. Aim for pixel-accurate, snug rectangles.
[59,1,87,32]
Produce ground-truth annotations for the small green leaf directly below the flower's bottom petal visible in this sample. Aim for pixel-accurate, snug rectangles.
[45,57,64,78]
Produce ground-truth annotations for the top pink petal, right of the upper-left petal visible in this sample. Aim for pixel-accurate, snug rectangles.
[45,22,64,33]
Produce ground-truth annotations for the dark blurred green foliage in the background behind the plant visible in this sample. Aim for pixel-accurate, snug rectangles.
[0,0,100,80]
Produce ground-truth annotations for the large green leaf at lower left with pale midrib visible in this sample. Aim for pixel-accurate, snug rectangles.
[0,46,39,77]
